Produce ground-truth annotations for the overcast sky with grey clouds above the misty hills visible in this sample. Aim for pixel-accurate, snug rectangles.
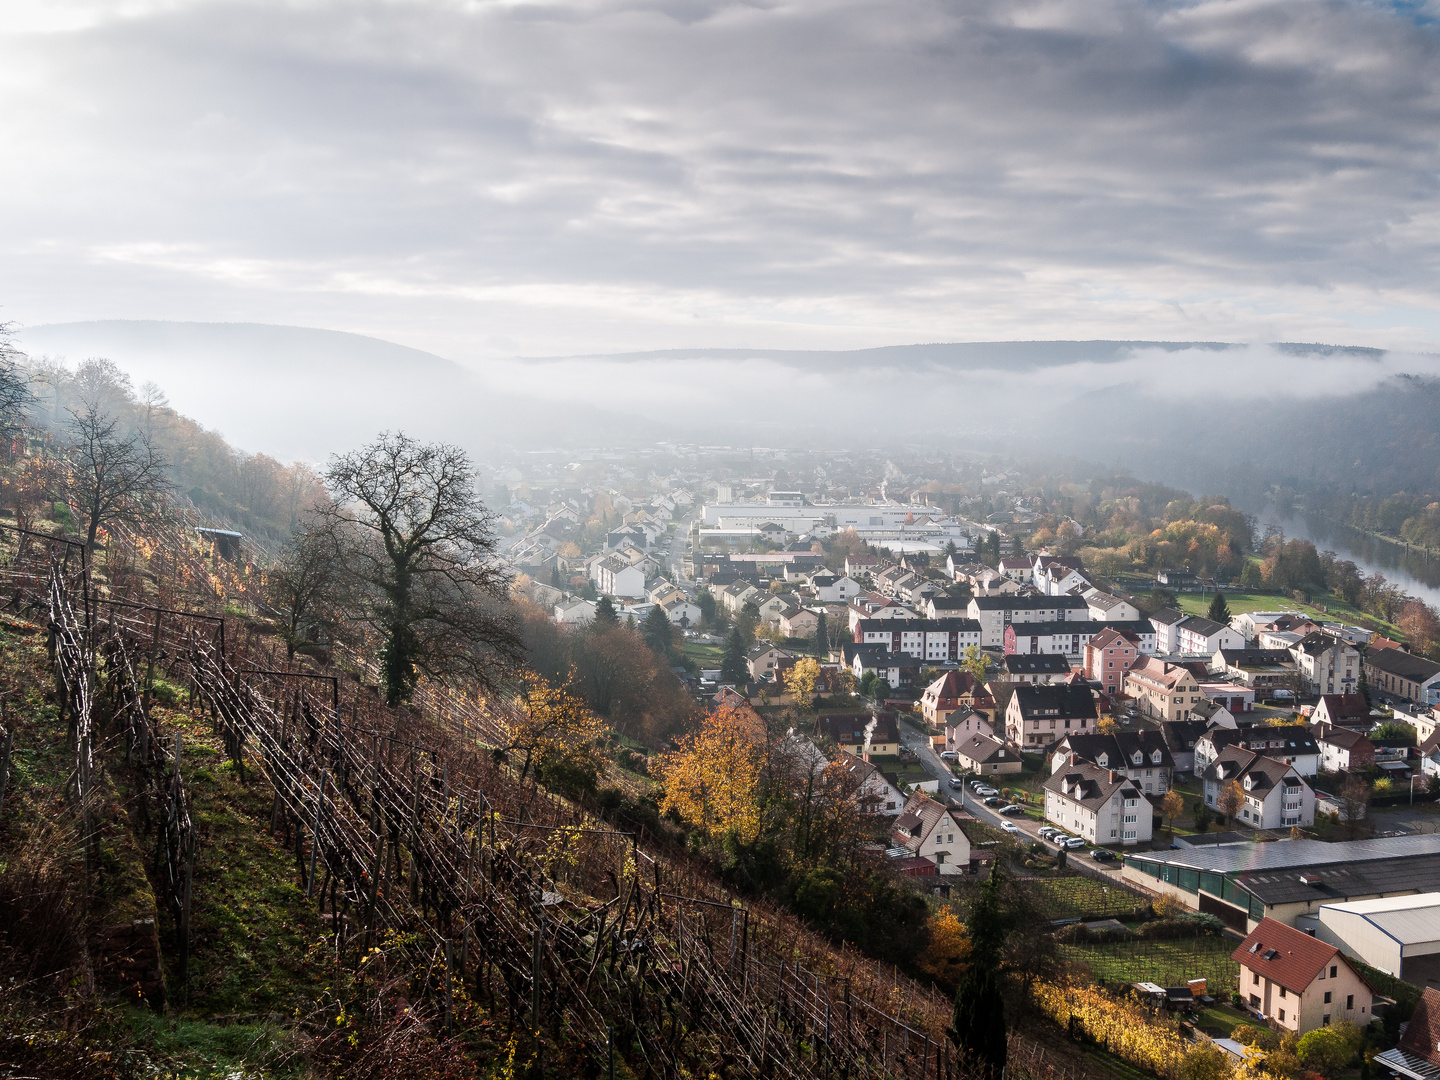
[0,0,1440,361]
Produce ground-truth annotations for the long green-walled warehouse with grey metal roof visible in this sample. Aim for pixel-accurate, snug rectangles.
[1123,834,1440,932]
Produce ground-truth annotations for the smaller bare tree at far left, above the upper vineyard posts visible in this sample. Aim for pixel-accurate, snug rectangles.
[56,403,170,550]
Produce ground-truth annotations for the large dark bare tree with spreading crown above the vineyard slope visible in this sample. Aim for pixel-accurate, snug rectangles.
[318,432,523,704]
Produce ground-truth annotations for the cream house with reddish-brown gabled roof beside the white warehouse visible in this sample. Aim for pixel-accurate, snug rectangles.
[1230,919,1375,1035]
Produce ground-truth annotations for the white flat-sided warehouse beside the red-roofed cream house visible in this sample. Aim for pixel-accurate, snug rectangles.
[1313,893,1440,988]
